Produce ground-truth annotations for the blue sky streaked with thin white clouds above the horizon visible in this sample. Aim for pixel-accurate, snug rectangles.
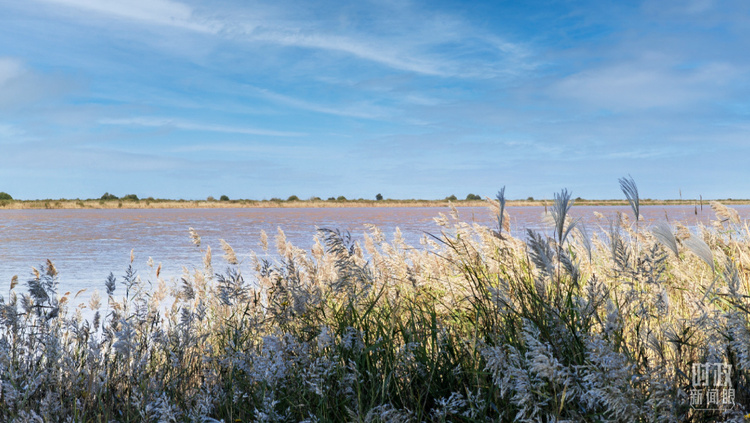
[0,0,750,199]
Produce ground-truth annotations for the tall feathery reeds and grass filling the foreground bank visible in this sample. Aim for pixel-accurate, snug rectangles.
[0,179,750,422]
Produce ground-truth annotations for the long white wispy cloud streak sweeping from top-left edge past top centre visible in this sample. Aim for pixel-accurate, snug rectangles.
[30,0,530,78]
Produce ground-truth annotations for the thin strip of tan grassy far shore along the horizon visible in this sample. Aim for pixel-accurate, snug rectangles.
[0,199,750,210]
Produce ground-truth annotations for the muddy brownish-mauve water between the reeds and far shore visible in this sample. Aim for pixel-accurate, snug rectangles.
[0,206,750,297]
